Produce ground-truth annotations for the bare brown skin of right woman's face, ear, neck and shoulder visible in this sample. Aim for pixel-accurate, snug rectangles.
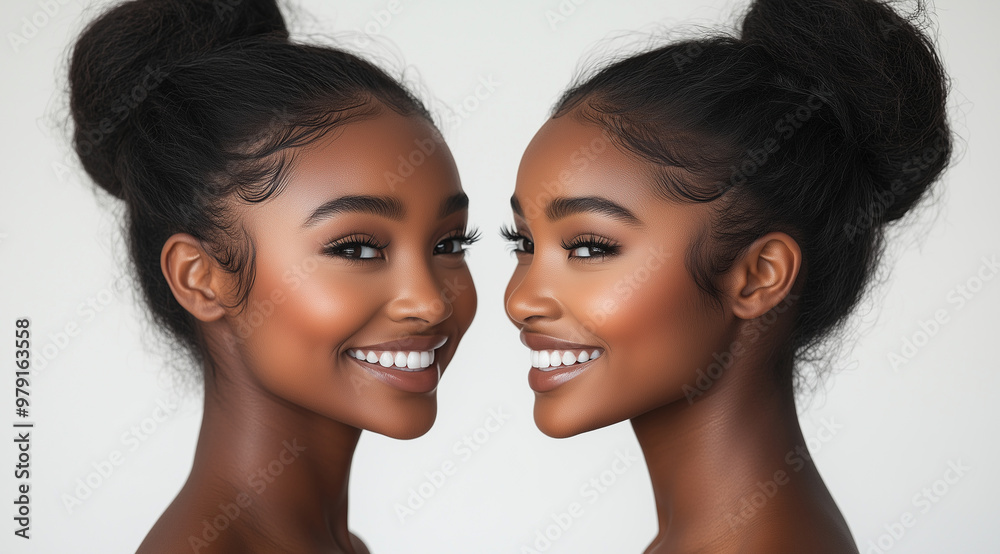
[505,112,857,554]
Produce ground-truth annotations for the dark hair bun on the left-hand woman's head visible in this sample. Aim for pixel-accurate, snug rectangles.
[69,0,288,198]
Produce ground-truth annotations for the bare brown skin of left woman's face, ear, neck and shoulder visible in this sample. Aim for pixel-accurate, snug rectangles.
[139,110,476,554]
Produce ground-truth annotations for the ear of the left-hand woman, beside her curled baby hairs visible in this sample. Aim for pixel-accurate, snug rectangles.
[160,233,226,322]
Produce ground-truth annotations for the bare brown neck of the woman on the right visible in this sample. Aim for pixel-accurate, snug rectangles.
[632,348,828,552]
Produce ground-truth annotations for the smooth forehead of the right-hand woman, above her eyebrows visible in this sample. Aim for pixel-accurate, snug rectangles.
[515,112,652,204]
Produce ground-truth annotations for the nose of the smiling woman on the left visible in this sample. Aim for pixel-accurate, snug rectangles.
[386,260,454,326]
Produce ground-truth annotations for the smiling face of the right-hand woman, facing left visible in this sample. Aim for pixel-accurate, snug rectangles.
[505,114,730,437]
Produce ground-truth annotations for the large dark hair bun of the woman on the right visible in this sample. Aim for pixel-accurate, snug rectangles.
[741,0,952,222]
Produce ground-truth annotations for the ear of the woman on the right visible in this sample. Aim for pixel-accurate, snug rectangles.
[728,232,802,319]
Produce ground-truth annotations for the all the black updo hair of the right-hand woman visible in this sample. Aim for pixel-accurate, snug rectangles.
[553,0,952,388]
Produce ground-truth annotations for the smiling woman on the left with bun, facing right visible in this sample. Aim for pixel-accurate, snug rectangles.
[70,0,476,553]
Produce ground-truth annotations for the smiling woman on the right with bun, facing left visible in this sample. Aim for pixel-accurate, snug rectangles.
[502,0,951,554]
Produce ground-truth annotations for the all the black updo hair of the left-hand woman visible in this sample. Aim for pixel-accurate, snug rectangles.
[69,0,431,380]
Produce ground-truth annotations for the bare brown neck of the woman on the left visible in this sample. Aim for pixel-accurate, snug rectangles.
[189,368,361,553]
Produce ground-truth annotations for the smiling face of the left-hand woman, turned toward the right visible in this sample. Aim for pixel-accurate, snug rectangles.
[224,110,476,438]
